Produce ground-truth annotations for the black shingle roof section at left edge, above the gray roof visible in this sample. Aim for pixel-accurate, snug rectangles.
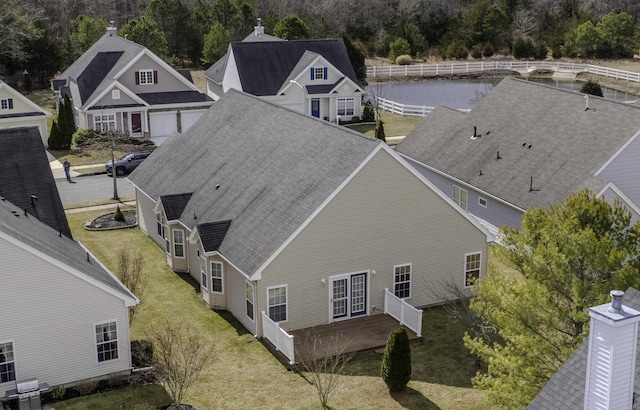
[0,127,71,238]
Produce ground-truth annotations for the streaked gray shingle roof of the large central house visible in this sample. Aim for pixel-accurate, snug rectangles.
[129,91,382,274]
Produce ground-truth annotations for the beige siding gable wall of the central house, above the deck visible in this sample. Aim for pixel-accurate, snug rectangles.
[258,151,487,330]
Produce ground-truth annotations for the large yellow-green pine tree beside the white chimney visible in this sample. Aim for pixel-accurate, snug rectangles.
[464,190,640,408]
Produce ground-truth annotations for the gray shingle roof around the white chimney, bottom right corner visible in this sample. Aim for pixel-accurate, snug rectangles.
[527,288,640,410]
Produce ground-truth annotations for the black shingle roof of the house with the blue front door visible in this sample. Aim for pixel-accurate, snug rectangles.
[210,39,358,96]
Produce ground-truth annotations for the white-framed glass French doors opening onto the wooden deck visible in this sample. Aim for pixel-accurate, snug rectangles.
[329,272,367,321]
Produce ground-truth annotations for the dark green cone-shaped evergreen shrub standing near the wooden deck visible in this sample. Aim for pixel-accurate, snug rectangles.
[381,327,411,392]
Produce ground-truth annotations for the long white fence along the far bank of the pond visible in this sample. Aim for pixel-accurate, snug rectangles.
[367,61,640,82]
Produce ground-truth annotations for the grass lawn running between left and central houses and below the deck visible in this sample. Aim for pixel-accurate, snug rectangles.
[61,211,492,410]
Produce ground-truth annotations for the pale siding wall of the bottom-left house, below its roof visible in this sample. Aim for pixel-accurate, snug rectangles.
[0,239,131,397]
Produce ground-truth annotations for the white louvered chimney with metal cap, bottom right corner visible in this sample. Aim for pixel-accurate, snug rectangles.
[584,290,640,410]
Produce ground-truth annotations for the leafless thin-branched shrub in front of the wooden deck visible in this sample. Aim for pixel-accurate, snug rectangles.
[299,328,358,409]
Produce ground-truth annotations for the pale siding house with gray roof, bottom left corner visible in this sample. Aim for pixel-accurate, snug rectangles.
[0,201,138,400]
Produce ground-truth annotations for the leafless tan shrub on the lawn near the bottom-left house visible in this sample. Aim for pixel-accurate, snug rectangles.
[148,322,214,409]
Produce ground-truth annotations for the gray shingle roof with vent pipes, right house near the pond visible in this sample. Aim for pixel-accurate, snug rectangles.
[396,78,640,209]
